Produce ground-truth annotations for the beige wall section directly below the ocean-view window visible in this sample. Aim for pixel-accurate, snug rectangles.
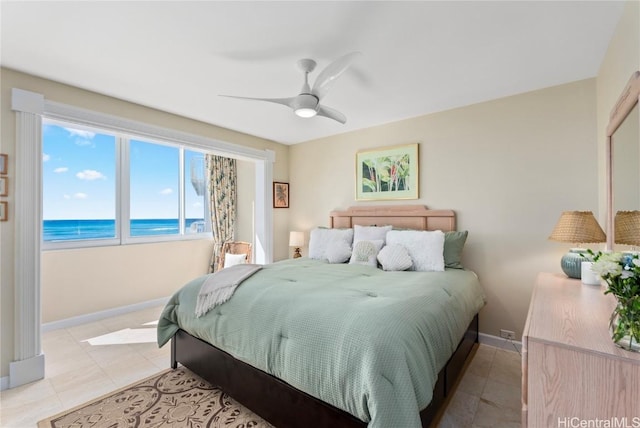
[41,240,213,323]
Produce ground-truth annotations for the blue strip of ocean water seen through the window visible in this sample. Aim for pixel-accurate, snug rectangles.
[42,218,204,241]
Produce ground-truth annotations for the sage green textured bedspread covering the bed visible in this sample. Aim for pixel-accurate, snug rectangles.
[158,258,484,428]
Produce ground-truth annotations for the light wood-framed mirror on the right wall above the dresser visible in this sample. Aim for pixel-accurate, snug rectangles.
[606,72,640,250]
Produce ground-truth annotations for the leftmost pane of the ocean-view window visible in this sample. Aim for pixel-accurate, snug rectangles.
[42,122,117,241]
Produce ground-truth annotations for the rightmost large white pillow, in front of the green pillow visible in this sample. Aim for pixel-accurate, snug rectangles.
[387,230,444,272]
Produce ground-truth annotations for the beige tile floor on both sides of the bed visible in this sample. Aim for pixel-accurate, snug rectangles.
[0,307,520,428]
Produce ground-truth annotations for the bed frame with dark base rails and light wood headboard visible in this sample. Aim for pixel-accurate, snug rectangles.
[171,205,478,428]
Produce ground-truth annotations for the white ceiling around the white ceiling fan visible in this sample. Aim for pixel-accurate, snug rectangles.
[0,0,624,144]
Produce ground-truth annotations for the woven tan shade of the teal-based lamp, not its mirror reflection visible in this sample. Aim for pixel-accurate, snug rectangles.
[549,211,607,244]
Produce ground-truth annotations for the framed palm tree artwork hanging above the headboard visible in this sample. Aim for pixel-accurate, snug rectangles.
[356,143,419,201]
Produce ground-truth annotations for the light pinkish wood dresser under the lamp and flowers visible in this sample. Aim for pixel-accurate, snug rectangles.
[522,273,640,428]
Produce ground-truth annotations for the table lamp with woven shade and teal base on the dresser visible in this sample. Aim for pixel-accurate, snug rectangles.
[549,211,606,279]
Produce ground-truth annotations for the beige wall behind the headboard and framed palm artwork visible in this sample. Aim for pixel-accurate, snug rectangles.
[289,79,598,337]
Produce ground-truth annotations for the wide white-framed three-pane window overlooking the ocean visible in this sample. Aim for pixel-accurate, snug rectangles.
[42,120,211,248]
